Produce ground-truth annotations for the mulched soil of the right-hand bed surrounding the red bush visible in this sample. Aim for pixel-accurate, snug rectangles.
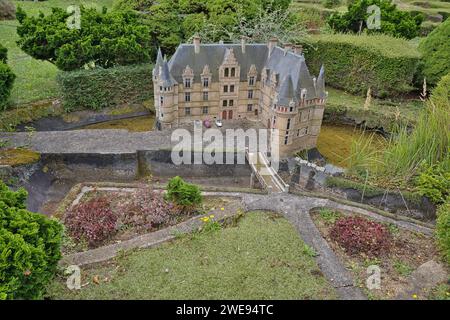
[311,208,448,299]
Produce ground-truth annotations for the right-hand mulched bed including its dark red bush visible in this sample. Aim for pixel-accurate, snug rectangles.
[311,208,446,299]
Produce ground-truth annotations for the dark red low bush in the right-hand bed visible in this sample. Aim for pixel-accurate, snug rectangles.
[330,217,392,256]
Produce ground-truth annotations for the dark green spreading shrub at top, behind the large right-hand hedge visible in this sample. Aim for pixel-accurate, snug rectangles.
[328,0,424,39]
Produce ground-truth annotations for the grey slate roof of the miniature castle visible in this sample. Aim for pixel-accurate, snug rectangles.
[162,44,325,104]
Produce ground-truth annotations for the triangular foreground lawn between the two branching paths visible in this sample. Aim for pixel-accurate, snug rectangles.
[48,212,337,299]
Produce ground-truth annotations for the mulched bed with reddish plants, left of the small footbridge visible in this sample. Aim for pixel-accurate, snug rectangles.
[62,187,236,254]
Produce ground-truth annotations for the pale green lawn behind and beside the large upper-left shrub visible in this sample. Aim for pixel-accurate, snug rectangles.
[0,0,114,105]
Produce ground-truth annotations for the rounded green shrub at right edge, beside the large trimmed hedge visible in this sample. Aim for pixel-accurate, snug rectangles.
[419,20,450,85]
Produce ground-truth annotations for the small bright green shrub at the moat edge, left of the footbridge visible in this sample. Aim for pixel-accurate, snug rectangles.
[167,177,202,207]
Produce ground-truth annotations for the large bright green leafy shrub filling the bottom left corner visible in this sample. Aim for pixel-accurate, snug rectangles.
[0,182,63,299]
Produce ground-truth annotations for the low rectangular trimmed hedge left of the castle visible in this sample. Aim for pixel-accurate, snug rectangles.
[57,64,153,111]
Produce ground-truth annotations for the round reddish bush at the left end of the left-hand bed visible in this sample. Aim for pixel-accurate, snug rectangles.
[64,198,118,247]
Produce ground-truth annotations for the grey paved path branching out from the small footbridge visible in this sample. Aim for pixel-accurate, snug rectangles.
[62,192,433,300]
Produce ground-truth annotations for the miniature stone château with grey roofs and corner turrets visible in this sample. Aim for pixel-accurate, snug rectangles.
[153,37,327,155]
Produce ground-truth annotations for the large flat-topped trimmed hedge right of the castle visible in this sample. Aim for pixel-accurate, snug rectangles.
[305,34,420,98]
